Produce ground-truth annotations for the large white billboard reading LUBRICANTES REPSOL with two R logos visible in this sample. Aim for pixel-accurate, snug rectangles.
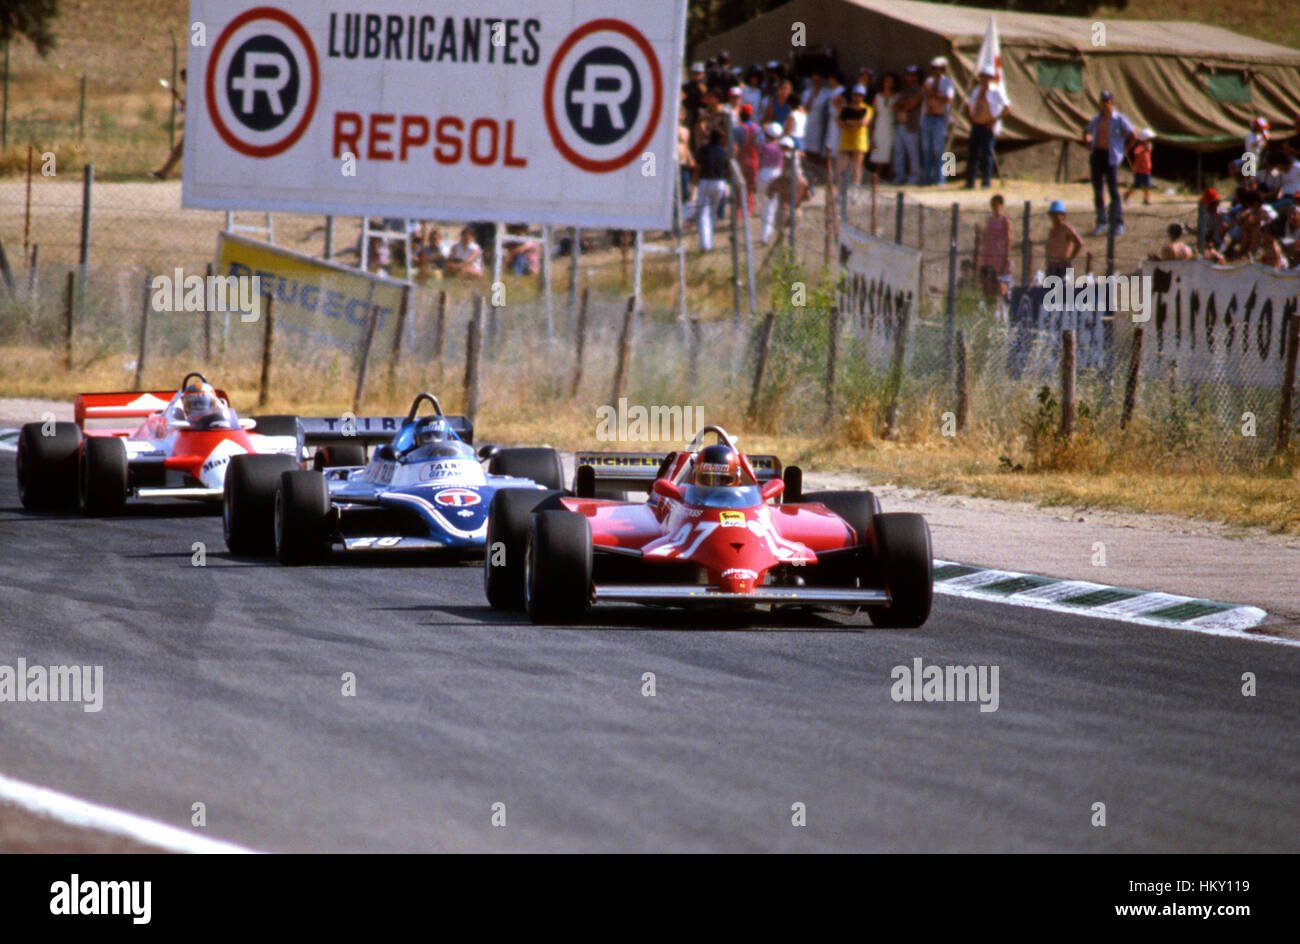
[183,0,686,229]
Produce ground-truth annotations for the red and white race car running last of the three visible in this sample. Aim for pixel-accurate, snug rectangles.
[18,372,365,515]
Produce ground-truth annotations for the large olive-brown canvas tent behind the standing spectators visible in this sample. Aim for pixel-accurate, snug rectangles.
[694,0,1300,151]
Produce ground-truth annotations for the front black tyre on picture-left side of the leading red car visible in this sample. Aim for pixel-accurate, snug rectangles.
[524,511,592,623]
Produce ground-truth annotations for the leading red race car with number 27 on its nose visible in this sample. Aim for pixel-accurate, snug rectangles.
[484,426,933,627]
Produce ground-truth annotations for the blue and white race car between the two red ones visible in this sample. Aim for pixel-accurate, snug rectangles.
[224,393,564,564]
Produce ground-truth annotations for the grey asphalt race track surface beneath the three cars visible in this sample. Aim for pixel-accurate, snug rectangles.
[0,454,1300,852]
